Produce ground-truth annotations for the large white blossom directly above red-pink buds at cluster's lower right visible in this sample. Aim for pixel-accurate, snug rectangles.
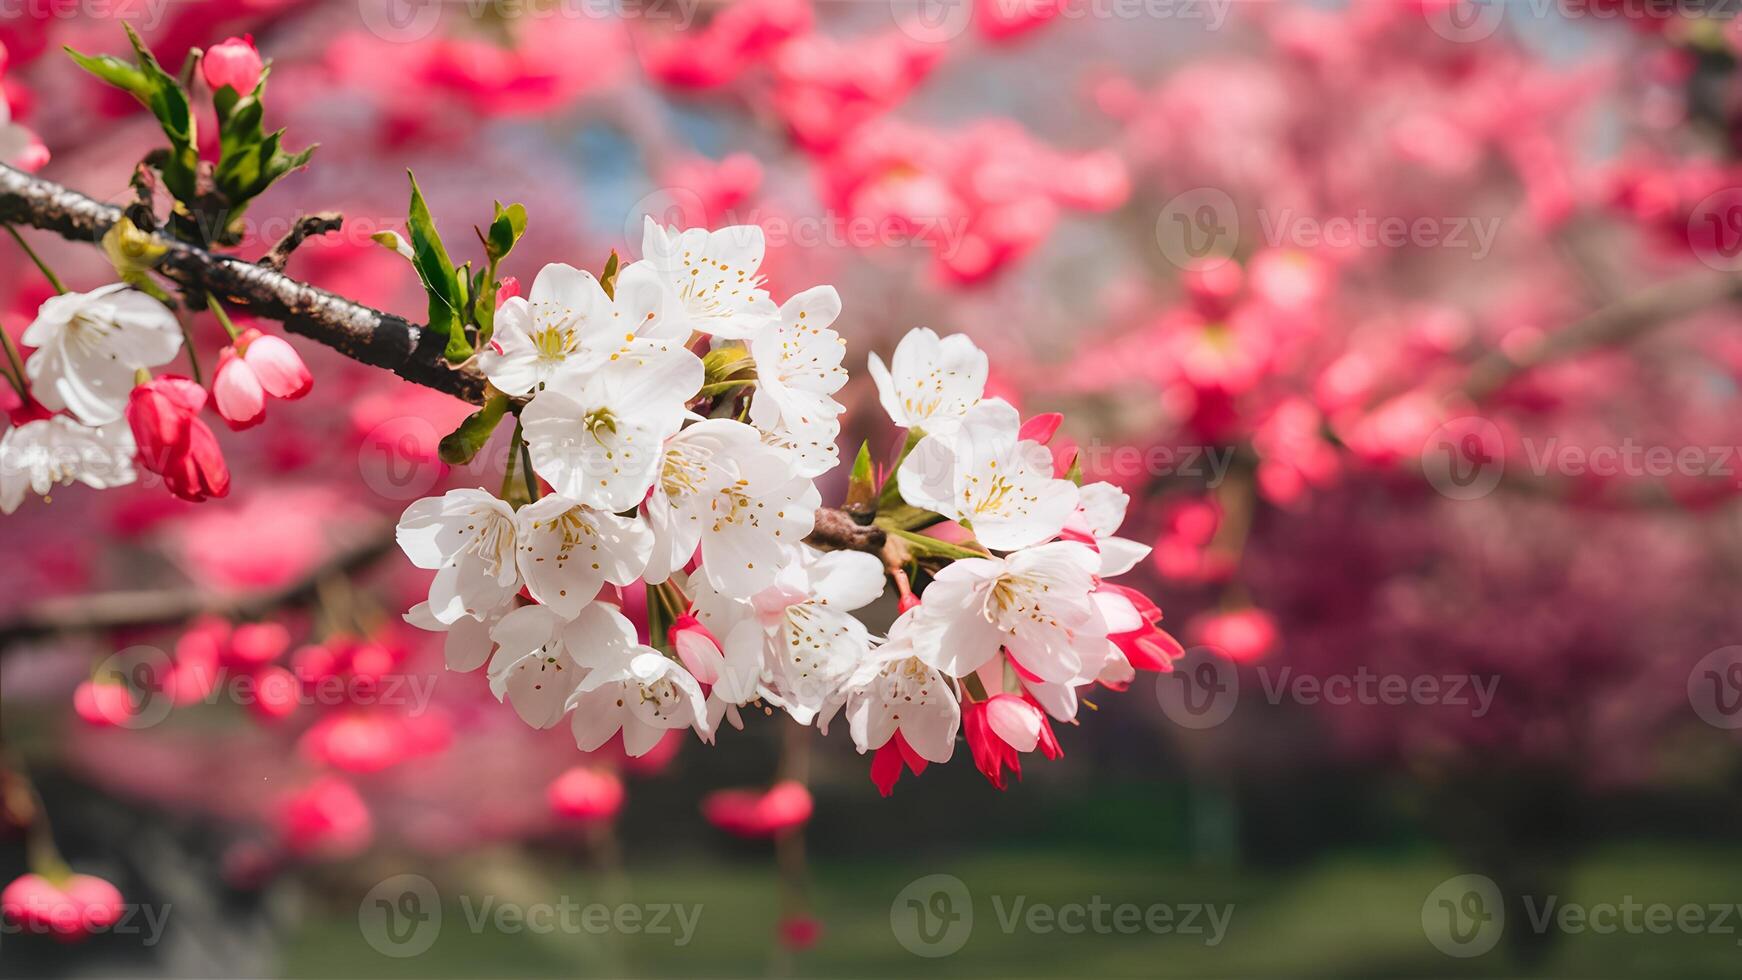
[908,541,1108,684]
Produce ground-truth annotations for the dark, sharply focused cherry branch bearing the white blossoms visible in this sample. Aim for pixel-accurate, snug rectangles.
[0,164,885,560]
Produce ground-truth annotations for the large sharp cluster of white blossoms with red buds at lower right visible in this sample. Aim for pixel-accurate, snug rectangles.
[397,219,1179,792]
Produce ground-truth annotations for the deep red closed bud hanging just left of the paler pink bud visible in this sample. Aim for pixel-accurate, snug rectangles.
[127,374,230,503]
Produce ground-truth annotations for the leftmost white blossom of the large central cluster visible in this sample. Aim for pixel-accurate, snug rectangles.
[395,489,521,625]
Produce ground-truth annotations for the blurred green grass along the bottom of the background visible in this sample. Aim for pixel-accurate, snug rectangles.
[284,842,1742,978]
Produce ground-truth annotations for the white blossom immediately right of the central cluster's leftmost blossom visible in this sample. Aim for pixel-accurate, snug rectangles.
[514,493,653,618]
